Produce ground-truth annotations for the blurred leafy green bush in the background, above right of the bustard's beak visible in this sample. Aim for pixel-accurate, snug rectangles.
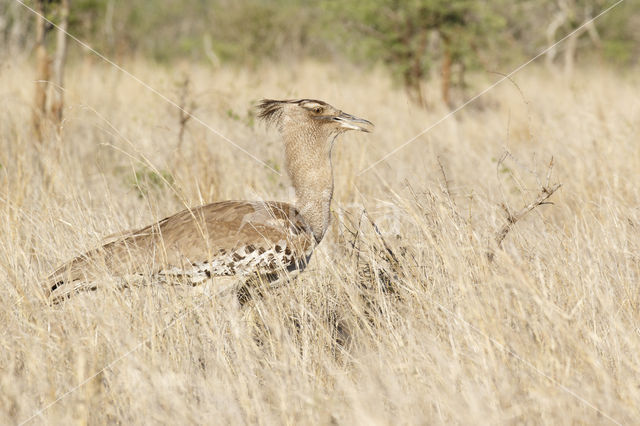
[327,0,505,100]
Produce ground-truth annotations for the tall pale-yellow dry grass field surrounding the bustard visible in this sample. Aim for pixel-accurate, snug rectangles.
[0,60,640,425]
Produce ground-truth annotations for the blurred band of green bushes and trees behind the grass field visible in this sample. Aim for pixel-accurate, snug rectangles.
[0,0,640,104]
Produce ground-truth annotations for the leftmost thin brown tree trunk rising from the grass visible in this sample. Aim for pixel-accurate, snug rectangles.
[33,0,51,142]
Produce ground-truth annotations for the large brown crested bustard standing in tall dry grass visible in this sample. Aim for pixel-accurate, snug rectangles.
[44,99,374,303]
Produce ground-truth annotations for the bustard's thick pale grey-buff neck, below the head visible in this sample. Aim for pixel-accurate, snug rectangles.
[283,129,334,243]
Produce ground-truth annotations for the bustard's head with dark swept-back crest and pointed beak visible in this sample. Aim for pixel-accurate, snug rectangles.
[258,99,373,136]
